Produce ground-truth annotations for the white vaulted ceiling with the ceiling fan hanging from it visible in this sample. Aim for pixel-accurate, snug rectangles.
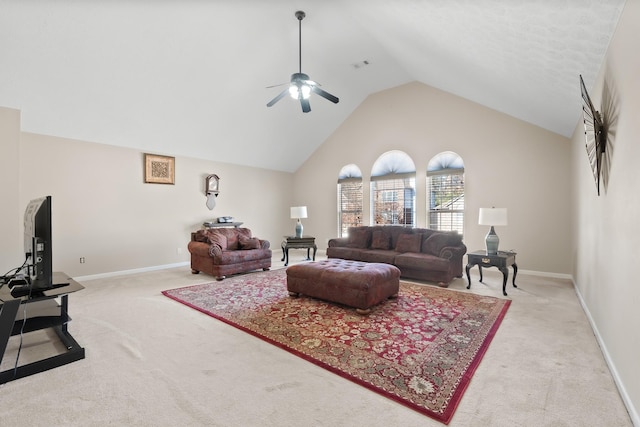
[0,0,624,171]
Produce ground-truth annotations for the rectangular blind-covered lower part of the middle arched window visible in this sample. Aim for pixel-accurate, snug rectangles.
[371,176,416,227]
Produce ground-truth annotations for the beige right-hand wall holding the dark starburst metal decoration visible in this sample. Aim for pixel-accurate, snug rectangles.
[571,0,640,425]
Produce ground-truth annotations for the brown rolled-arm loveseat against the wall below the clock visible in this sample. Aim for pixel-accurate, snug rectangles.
[188,228,271,280]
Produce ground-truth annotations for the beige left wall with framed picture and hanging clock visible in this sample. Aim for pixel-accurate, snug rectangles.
[0,109,293,277]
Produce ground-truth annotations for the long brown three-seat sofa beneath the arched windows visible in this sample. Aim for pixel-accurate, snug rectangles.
[327,225,467,286]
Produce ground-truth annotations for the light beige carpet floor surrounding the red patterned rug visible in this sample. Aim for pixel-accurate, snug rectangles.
[0,252,631,427]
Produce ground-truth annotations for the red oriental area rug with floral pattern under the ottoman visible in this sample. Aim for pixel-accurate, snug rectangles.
[162,269,510,424]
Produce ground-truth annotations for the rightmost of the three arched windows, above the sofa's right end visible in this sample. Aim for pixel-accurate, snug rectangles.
[427,151,464,234]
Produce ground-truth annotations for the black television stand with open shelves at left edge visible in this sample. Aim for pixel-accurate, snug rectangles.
[0,272,84,384]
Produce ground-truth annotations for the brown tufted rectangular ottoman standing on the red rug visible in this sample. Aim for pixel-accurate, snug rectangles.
[287,258,400,314]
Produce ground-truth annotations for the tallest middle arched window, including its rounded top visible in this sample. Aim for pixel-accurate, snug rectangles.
[371,150,416,227]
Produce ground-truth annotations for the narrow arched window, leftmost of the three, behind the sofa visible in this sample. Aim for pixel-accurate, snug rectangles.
[338,163,362,237]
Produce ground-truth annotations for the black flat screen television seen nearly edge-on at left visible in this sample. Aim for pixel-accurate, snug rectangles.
[24,196,53,292]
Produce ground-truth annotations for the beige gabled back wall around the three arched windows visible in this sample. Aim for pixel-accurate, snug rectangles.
[294,83,572,275]
